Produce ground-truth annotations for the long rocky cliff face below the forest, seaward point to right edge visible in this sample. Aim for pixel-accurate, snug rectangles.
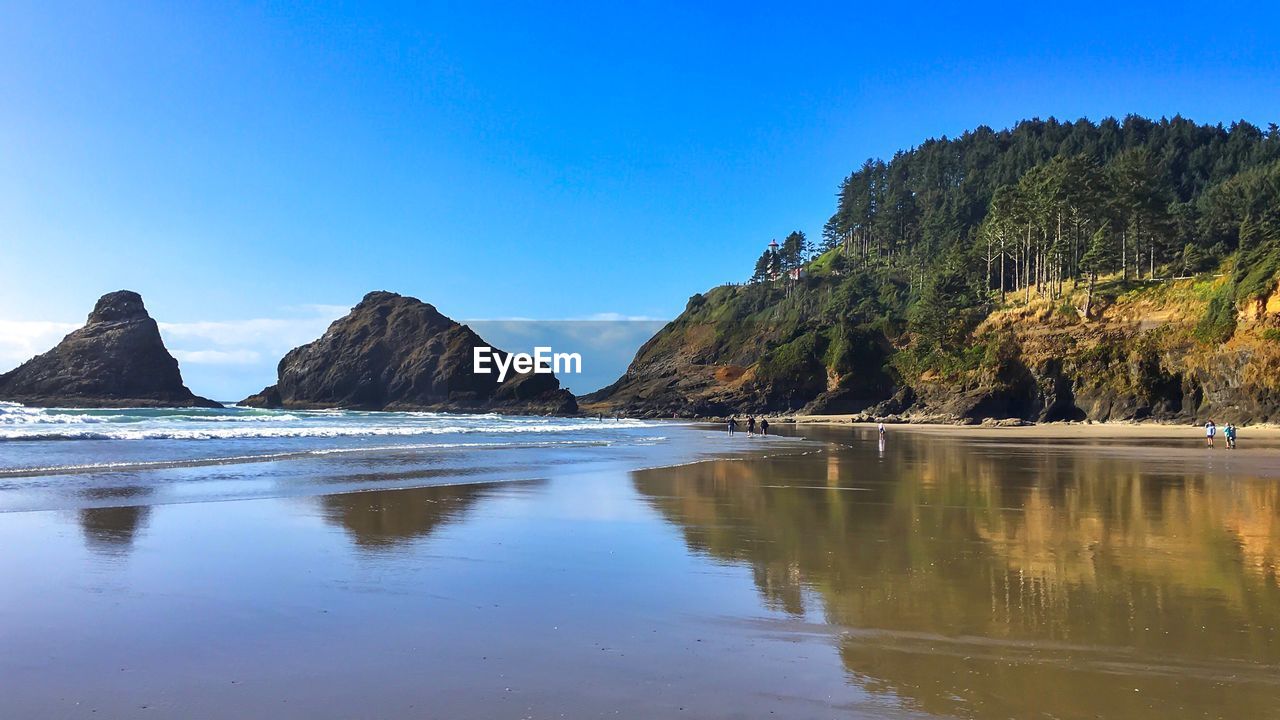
[584,272,1280,423]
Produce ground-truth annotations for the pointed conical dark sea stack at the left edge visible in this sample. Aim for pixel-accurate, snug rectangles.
[0,290,221,407]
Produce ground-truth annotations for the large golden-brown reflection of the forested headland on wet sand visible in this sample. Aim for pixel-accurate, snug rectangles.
[634,433,1280,717]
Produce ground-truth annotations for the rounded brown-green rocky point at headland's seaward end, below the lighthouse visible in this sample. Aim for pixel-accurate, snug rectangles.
[581,284,893,418]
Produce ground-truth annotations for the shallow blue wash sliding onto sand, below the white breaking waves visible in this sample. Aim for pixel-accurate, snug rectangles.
[0,418,798,515]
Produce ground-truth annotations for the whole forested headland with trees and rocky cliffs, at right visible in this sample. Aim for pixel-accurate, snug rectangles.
[589,115,1280,421]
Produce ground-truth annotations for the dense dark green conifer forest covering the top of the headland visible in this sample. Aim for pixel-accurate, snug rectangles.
[753,115,1280,358]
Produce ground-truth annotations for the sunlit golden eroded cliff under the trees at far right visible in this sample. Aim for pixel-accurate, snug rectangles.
[901,281,1280,423]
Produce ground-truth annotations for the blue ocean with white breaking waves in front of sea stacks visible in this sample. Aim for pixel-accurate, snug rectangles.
[0,402,711,511]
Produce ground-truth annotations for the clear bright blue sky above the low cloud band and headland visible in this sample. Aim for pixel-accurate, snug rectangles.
[0,1,1280,391]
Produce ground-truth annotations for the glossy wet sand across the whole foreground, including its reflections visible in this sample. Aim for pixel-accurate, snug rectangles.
[0,425,1280,719]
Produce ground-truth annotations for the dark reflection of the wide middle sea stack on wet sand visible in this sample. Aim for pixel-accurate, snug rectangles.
[320,484,489,548]
